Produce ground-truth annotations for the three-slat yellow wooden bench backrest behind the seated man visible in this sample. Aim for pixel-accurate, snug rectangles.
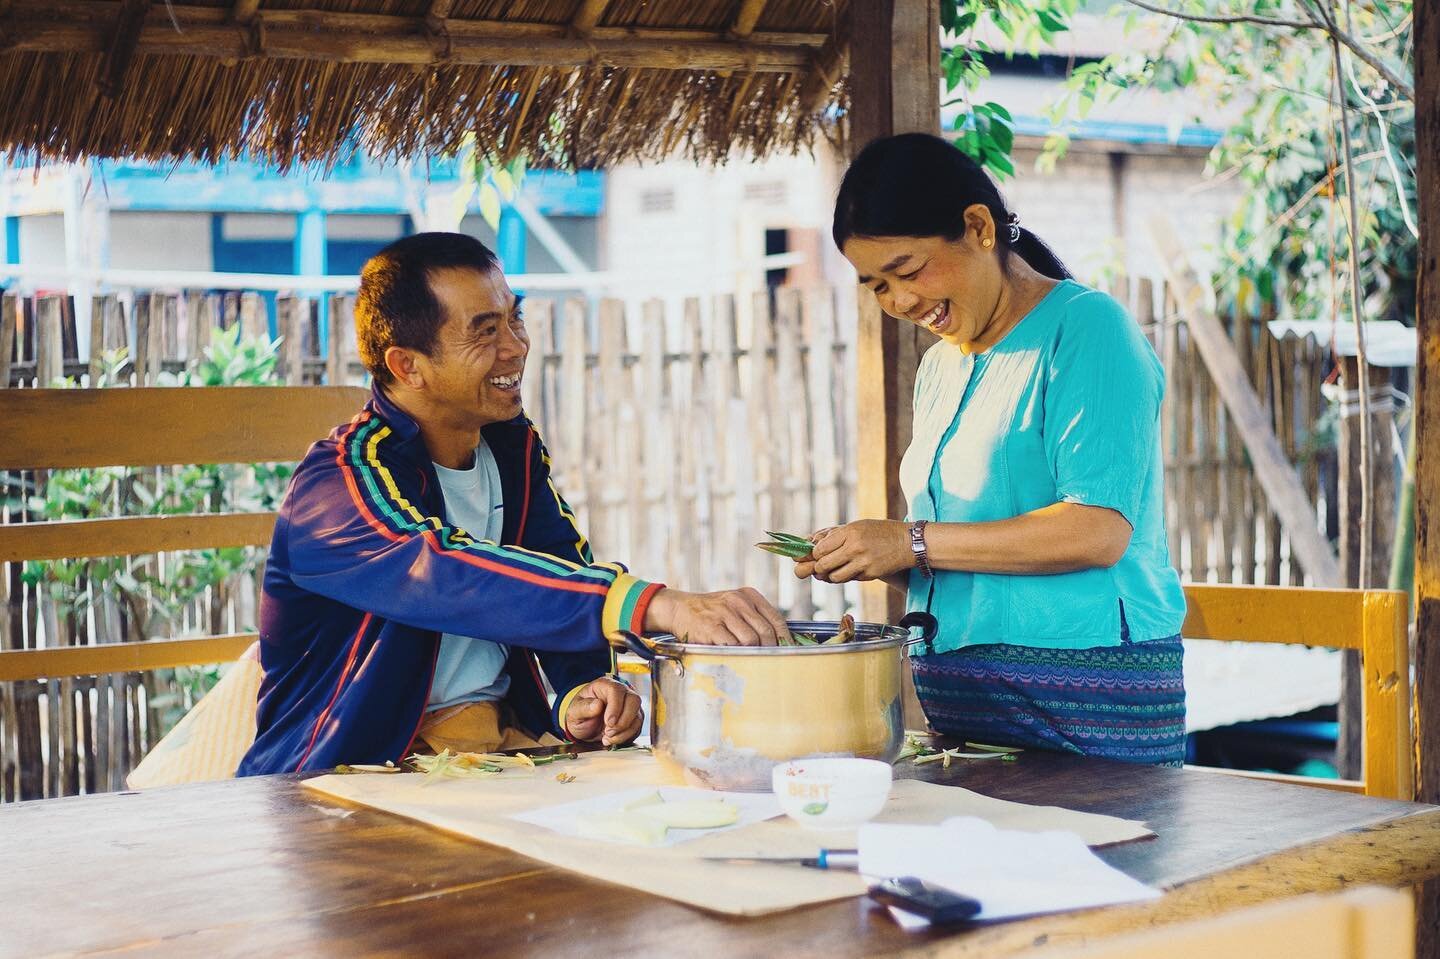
[0,386,369,681]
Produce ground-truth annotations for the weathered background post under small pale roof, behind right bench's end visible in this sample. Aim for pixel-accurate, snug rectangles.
[1336,357,1395,779]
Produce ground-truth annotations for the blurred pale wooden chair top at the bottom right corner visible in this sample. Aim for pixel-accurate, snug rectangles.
[1042,887,1416,959]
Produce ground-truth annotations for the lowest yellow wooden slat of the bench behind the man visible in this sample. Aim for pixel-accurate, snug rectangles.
[0,632,256,683]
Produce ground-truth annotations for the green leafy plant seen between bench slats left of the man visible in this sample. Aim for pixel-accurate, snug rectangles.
[22,328,294,731]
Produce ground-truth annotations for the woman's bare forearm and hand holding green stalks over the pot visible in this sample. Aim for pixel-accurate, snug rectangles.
[795,503,1130,586]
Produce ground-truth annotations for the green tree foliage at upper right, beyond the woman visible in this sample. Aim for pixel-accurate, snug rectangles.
[942,0,1417,323]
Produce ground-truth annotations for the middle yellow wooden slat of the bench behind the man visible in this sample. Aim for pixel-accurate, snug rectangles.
[0,513,275,563]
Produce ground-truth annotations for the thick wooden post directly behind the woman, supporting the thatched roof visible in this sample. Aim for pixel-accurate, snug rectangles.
[848,0,940,622]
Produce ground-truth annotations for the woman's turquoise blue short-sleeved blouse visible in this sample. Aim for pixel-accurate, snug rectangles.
[900,281,1185,652]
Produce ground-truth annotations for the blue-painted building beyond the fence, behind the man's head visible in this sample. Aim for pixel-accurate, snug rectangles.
[0,156,605,282]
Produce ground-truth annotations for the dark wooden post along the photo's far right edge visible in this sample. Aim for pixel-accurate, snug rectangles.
[1411,3,1440,958]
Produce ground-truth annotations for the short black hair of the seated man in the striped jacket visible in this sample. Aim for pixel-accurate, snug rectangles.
[356,233,500,383]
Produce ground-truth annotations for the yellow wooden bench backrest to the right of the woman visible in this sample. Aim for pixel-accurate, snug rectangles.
[1181,583,1416,799]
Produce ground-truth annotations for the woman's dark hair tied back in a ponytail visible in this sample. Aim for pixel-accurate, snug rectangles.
[831,134,1070,279]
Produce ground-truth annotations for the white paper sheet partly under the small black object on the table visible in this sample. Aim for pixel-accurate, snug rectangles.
[860,818,1161,927]
